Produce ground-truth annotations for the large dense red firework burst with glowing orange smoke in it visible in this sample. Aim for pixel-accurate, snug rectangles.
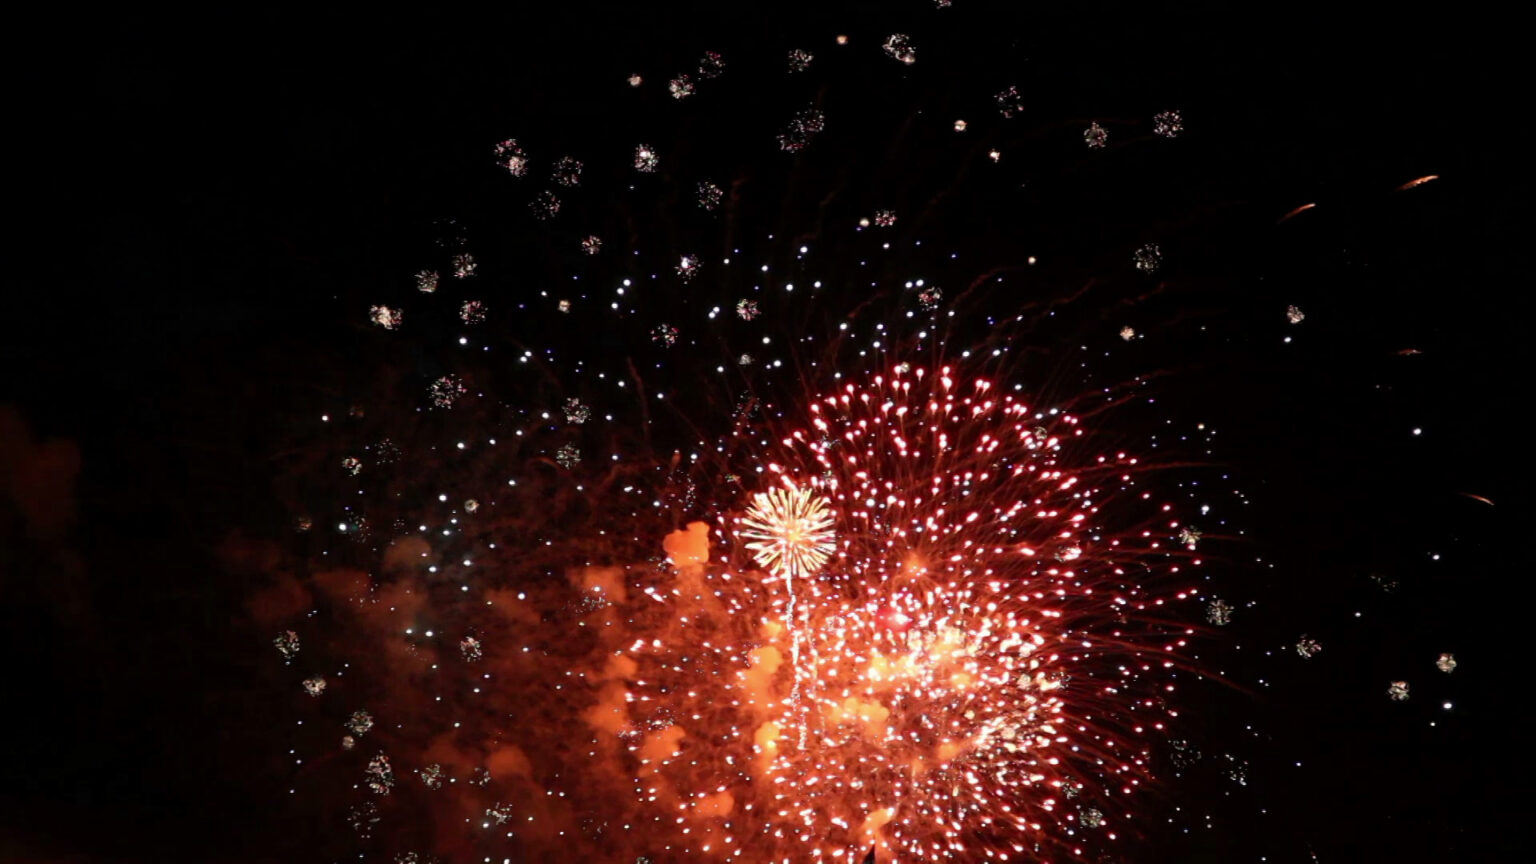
[611,369,1198,862]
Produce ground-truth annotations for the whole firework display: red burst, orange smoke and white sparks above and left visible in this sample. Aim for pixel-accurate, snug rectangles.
[264,10,1247,862]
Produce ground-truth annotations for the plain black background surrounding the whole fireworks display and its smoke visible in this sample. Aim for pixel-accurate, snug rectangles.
[0,0,1531,862]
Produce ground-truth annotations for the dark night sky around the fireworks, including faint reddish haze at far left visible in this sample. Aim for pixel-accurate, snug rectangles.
[0,0,1533,864]
